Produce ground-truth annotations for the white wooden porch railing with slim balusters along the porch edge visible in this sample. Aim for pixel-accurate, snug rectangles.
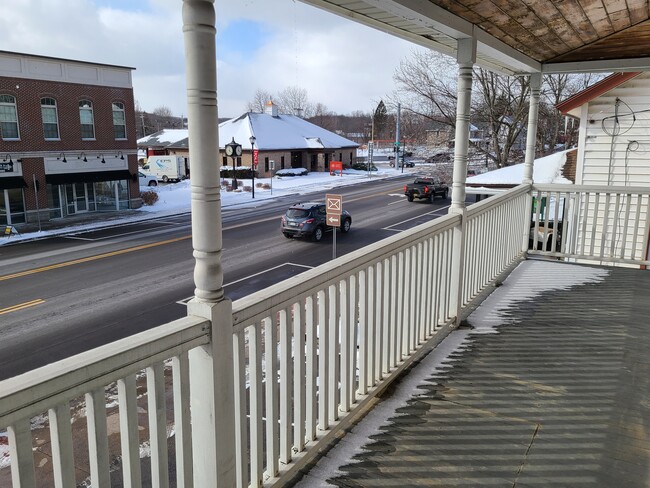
[0,185,649,488]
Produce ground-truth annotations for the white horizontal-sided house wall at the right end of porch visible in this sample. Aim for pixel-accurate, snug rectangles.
[570,73,650,264]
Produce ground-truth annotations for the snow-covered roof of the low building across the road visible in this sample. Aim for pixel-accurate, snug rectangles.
[219,112,359,151]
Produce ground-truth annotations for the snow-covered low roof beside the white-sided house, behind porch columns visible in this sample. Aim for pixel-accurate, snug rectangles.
[467,151,571,186]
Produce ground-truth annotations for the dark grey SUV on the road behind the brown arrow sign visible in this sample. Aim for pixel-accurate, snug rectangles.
[280,202,352,241]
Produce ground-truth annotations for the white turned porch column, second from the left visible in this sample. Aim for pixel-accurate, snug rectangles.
[449,38,476,326]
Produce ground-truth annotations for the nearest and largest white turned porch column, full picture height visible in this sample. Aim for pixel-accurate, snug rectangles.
[183,0,236,488]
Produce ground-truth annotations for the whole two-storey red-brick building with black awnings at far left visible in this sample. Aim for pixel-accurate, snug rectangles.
[0,51,141,226]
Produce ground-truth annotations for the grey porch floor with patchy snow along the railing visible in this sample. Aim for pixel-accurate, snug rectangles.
[297,260,650,488]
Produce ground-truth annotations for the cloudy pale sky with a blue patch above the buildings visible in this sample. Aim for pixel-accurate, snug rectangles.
[0,0,416,117]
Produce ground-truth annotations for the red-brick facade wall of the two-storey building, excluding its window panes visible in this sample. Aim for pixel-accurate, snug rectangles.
[0,53,142,224]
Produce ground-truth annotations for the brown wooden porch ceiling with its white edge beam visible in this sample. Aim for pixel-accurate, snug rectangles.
[301,0,650,74]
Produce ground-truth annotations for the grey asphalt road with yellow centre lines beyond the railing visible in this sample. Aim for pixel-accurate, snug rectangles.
[0,178,456,379]
